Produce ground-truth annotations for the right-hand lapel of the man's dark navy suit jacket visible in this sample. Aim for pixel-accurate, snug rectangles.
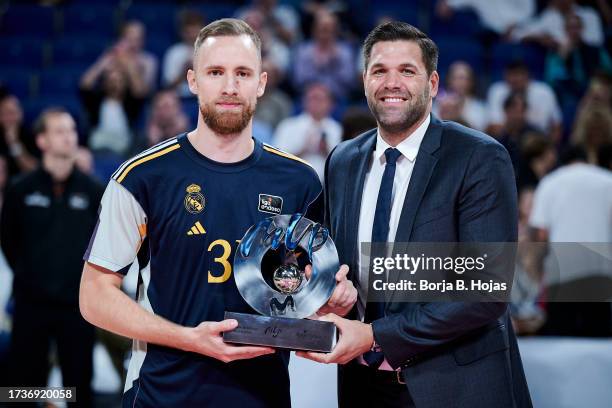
[387,115,442,308]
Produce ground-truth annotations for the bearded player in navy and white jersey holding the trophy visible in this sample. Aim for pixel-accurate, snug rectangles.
[80,19,357,407]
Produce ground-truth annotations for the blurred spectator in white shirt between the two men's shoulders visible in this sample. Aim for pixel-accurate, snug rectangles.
[274,83,342,180]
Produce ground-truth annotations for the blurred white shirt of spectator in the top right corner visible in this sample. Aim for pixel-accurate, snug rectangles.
[510,0,604,49]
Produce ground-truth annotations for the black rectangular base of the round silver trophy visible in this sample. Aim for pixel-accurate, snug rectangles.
[223,312,336,353]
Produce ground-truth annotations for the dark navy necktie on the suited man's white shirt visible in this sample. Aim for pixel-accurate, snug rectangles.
[363,147,402,368]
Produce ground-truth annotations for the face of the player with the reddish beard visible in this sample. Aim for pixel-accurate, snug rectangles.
[187,35,267,135]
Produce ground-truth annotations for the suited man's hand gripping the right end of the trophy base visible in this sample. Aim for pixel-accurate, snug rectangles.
[295,313,374,364]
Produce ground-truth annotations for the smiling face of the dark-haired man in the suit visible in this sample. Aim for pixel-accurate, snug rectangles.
[363,40,439,135]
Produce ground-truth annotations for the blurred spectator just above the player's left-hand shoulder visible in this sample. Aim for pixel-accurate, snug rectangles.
[145,89,189,151]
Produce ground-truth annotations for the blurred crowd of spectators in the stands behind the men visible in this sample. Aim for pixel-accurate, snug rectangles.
[0,0,612,402]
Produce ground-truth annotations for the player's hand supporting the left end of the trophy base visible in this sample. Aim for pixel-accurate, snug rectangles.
[186,319,275,363]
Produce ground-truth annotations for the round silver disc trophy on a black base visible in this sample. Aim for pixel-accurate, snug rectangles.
[223,214,339,352]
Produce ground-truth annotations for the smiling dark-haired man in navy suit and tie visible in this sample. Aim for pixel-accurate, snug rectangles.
[299,22,531,408]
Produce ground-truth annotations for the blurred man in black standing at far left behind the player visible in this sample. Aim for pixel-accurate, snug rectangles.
[0,109,103,407]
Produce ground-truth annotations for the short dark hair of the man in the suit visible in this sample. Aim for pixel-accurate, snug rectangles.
[363,21,438,75]
